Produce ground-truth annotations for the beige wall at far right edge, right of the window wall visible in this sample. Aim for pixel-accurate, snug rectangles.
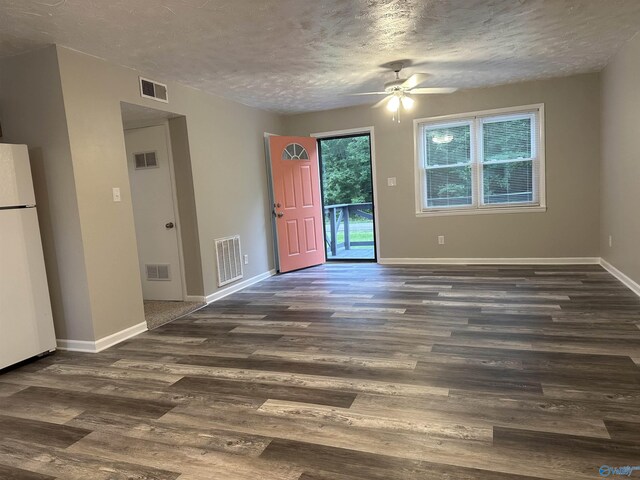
[600,36,640,283]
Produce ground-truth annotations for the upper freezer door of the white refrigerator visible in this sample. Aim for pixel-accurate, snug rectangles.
[0,143,36,208]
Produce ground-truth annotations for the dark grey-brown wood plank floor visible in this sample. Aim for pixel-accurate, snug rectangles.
[0,264,640,480]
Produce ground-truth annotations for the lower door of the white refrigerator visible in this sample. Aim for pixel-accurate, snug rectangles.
[0,208,56,368]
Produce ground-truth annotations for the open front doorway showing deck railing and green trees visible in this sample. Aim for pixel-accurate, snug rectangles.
[318,133,377,262]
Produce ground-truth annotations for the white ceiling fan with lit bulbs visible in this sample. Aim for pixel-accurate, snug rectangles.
[353,62,458,122]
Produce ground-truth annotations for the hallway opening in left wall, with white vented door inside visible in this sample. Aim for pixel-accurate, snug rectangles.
[121,103,202,329]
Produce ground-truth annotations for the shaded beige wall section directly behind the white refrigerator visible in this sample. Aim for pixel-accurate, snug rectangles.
[0,47,94,340]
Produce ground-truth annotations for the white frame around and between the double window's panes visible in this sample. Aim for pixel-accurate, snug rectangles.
[413,103,547,217]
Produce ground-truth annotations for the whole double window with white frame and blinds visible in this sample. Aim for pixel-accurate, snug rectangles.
[414,105,545,216]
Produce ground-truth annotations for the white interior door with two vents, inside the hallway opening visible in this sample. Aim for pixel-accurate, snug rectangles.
[125,125,183,300]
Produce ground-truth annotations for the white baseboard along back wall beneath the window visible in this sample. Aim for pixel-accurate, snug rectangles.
[378,257,600,265]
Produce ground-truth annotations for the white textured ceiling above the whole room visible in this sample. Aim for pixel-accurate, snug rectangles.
[0,0,640,113]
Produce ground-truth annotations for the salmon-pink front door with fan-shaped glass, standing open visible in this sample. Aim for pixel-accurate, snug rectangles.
[269,136,325,272]
